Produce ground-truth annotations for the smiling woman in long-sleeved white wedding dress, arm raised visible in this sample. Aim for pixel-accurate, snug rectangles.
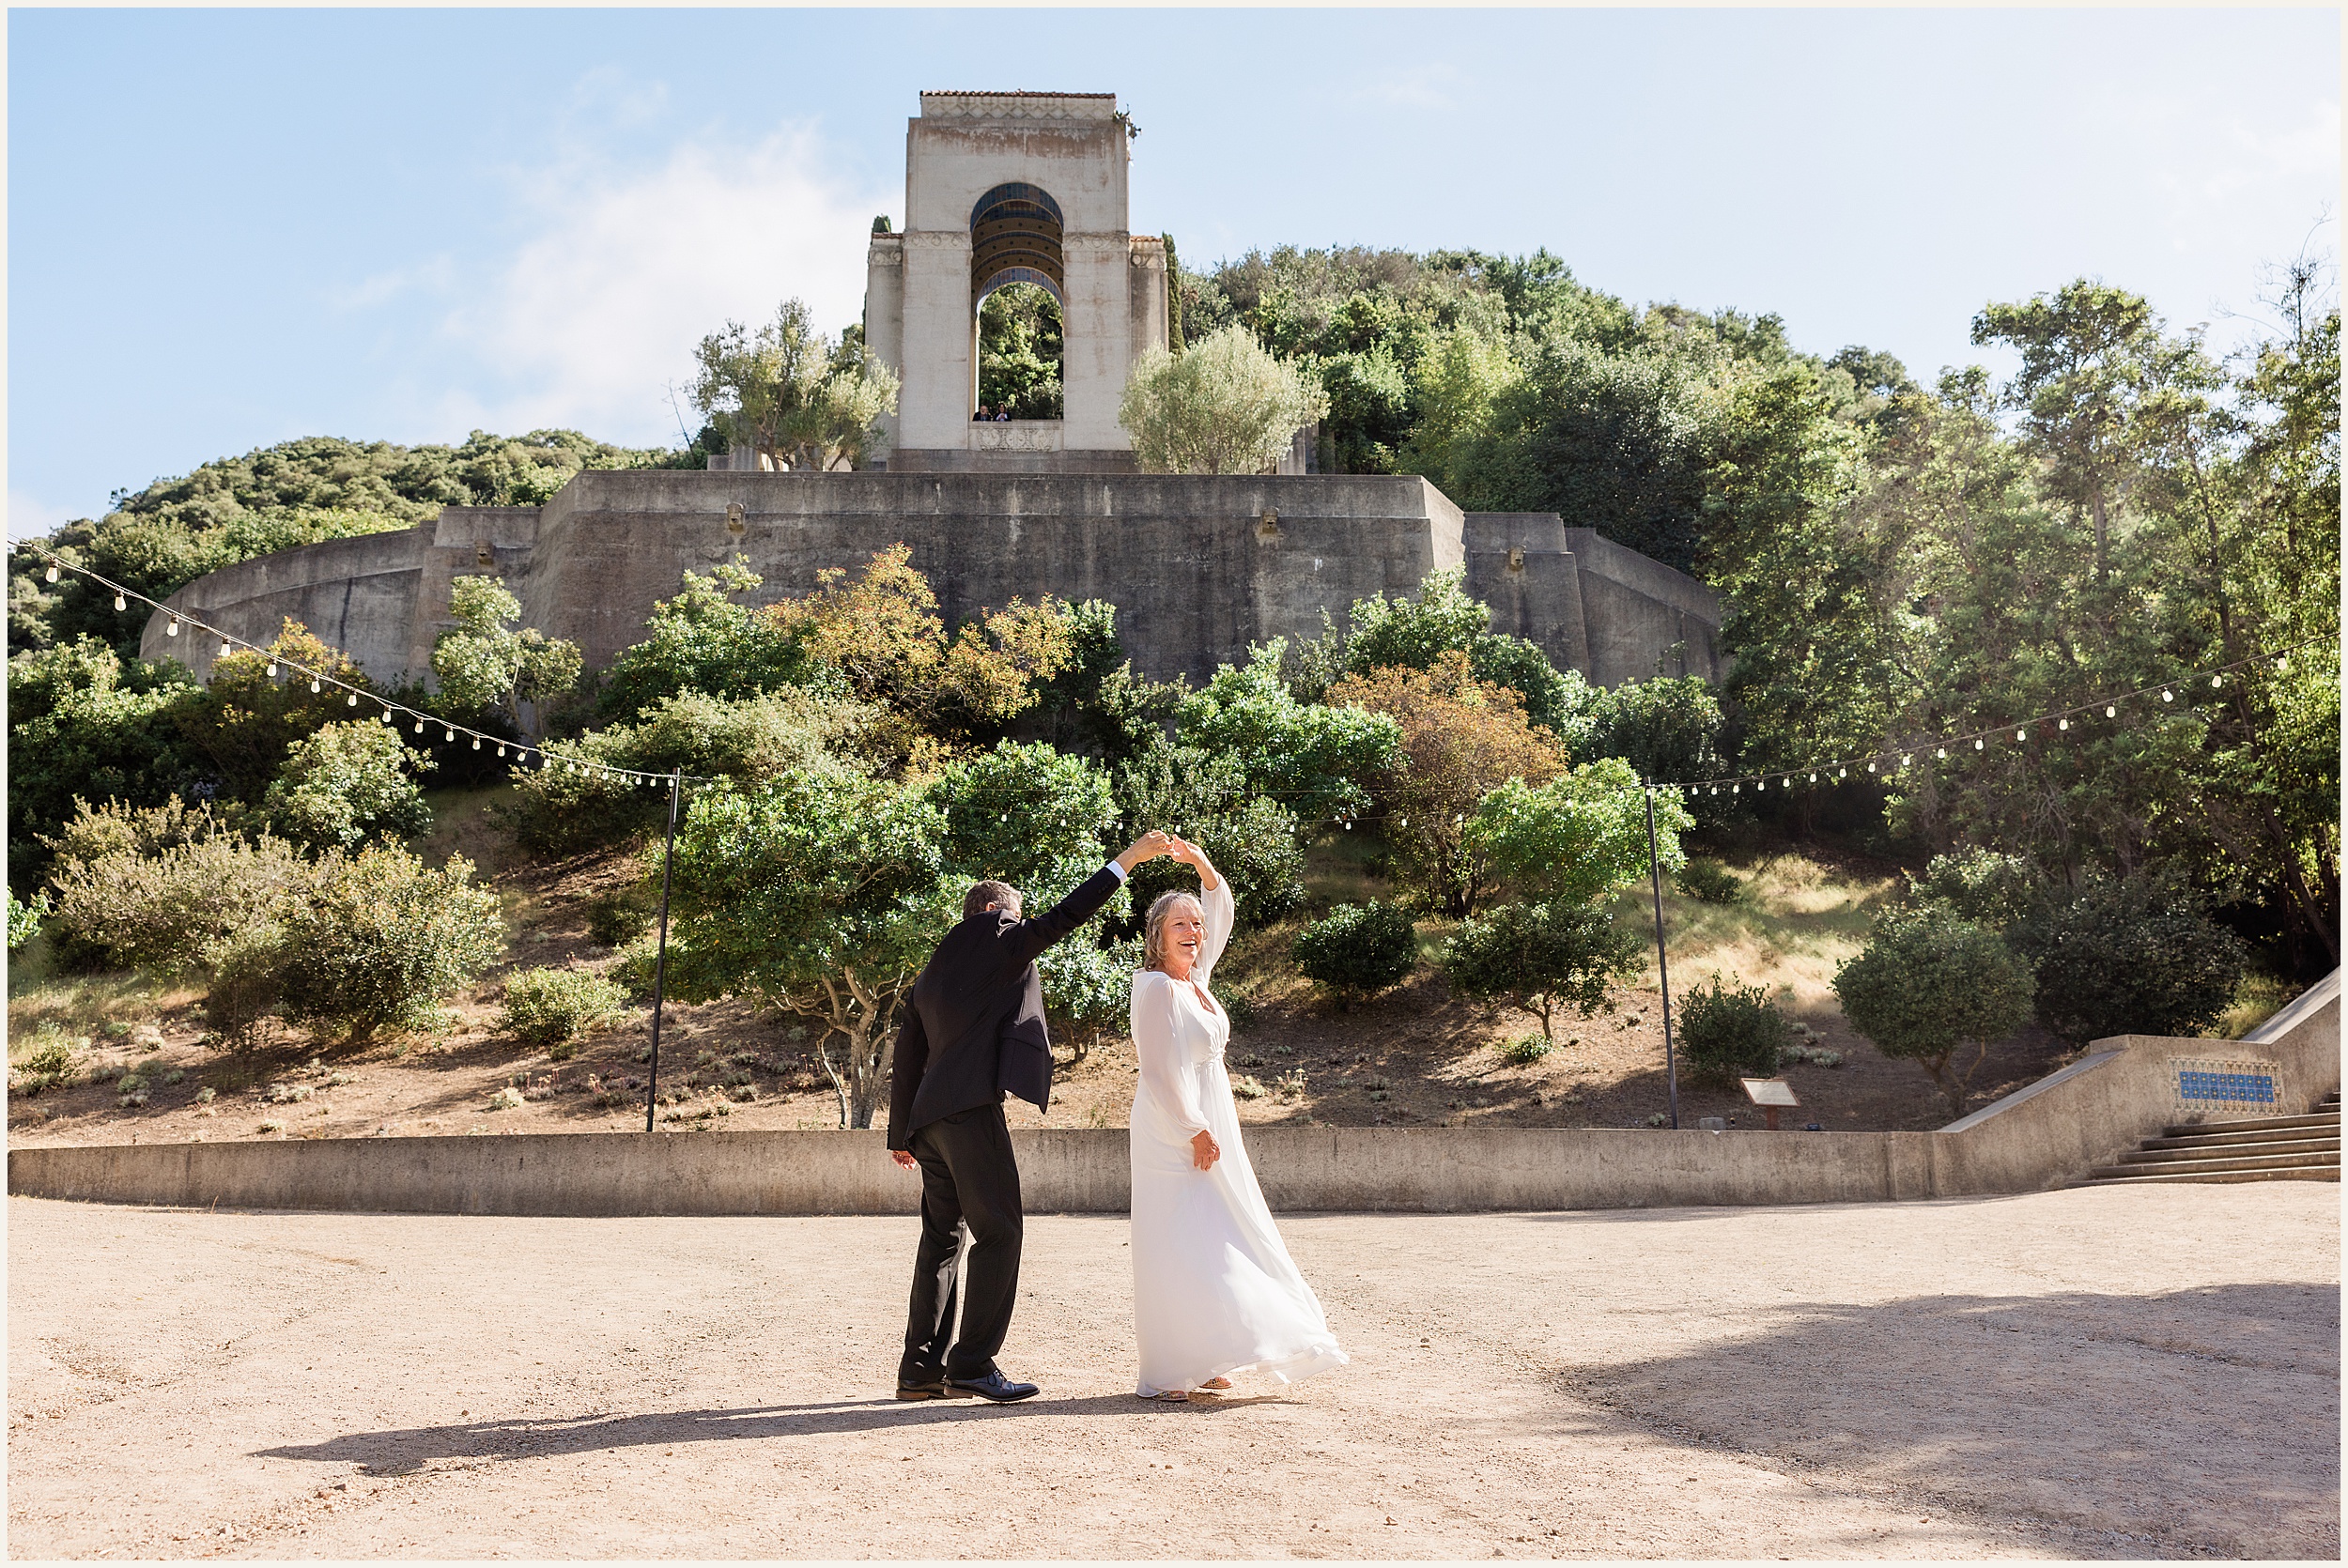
[1130,838,1346,1399]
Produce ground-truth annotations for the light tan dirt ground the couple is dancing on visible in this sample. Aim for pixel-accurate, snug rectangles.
[8,1183,2341,1559]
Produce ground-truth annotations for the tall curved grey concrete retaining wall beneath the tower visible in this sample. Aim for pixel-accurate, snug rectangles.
[141,469,1719,684]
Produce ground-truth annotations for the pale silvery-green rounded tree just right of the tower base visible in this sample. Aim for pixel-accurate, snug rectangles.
[1118,324,1329,474]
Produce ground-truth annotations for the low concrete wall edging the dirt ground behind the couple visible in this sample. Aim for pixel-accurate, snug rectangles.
[8,975,2341,1216]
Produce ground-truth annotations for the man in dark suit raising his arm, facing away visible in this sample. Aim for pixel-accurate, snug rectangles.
[888,834,1172,1404]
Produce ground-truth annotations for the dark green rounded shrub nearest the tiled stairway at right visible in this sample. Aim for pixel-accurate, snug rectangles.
[2015,878,2249,1045]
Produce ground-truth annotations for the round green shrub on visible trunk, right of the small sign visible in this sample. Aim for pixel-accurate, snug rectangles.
[1834,904,2031,1115]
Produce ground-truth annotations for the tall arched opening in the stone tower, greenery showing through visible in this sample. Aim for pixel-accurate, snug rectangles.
[970,186,1066,421]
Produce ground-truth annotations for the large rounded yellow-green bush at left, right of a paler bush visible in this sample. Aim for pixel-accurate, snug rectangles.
[280,848,505,1040]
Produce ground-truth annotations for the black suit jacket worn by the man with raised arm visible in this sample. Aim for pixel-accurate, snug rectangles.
[888,867,1125,1148]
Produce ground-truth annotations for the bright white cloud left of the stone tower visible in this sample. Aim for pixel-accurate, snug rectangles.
[434,130,895,441]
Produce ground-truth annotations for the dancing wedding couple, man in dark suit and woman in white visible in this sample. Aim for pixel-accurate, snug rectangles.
[888,831,1346,1404]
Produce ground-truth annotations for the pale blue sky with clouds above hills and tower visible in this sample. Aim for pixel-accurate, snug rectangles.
[8,9,2341,535]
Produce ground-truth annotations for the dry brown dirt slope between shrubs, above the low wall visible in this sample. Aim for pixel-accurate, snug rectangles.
[9,792,2064,1148]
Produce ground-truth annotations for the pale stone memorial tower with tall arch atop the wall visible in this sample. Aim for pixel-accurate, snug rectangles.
[864,92,1167,474]
